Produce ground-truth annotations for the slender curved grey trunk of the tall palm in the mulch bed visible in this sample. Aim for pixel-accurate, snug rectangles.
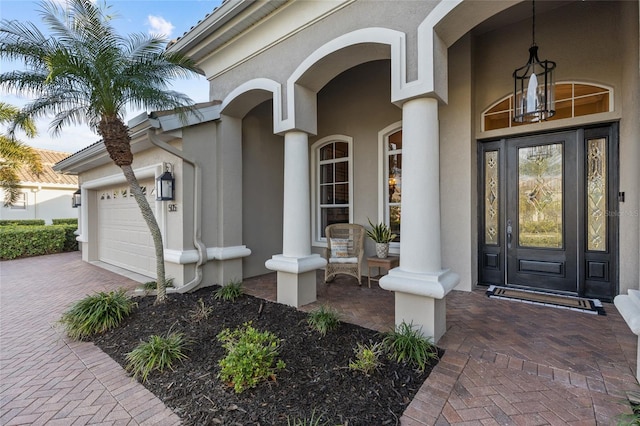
[120,165,167,304]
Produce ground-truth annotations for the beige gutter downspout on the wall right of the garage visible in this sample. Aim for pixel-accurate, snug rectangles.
[147,129,207,293]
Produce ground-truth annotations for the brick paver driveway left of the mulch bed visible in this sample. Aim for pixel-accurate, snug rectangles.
[0,253,180,426]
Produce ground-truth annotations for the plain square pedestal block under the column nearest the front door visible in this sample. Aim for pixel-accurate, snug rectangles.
[395,291,447,343]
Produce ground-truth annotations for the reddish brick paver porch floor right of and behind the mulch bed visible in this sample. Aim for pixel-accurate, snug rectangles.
[243,271,640,426]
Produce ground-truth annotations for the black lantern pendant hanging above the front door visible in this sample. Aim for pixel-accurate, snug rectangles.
[513,0,556,123]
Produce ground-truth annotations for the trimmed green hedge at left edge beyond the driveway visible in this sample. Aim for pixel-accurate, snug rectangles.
[0,225,78,260]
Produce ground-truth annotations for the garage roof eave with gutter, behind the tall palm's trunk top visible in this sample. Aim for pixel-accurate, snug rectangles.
[53,102,220,175]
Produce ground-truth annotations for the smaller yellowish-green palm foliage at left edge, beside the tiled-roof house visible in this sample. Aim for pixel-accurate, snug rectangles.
[0,102,42,207]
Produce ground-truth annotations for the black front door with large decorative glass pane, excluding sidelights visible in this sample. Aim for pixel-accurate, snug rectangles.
[504,132,581,293]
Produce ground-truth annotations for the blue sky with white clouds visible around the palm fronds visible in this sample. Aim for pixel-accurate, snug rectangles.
[0,0,221,153]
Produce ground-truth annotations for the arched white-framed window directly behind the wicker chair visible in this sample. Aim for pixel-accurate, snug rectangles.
[312,135,353,242]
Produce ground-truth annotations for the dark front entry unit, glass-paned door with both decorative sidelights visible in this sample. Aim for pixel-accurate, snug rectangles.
[479,125,618,300]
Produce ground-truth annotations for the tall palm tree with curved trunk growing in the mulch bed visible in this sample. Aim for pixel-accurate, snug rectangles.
[0,0,199,303]
